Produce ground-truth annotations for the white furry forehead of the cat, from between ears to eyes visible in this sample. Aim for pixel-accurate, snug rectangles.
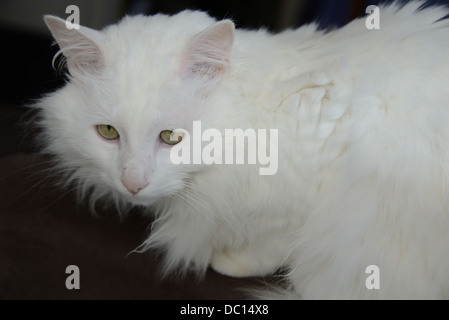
[79,11,219,130]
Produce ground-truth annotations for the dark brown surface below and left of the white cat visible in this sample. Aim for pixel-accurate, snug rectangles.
[0,110,262,299]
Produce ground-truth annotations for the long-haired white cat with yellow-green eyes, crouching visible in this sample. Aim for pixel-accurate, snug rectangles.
[37,1,449,299]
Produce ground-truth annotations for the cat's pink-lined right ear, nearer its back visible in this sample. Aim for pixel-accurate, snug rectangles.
[180,20,235,80]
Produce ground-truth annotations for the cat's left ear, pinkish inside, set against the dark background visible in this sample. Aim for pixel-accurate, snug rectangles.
[44,15,104,74]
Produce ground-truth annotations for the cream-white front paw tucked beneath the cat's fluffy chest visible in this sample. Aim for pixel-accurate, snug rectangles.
[210,250,276,278]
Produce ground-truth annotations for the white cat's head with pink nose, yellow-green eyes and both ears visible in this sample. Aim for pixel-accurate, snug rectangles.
[38,11,234,205]
